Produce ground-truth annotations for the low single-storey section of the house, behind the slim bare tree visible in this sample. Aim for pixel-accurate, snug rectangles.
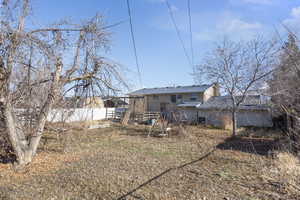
[196,95,273,128]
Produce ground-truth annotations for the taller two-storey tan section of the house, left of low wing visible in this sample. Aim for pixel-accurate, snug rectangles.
[128,84,220,113]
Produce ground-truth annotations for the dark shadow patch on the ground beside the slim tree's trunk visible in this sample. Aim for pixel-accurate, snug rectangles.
[217,136,278,156]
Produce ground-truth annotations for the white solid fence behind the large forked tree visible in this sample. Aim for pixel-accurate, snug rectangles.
[47,108,115,122]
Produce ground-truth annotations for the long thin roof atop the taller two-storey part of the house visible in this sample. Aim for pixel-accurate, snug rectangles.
[128,84,213,96]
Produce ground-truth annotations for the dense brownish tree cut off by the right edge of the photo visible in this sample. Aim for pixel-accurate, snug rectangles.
[268,31,300,151]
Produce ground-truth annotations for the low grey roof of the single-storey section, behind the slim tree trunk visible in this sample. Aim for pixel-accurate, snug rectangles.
[196,95,269,110]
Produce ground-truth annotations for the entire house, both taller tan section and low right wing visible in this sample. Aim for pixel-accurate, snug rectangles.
[129,84,273,128]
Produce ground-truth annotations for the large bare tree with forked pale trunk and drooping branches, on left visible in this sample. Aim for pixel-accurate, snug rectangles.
[0,0,125,166]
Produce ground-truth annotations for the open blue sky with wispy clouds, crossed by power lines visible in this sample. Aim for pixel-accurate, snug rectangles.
[32,0,300,88]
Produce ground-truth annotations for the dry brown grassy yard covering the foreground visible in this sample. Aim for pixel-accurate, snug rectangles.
[0,122,300,200]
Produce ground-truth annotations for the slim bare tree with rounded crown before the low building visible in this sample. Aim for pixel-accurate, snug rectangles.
[195,37,278,136]
